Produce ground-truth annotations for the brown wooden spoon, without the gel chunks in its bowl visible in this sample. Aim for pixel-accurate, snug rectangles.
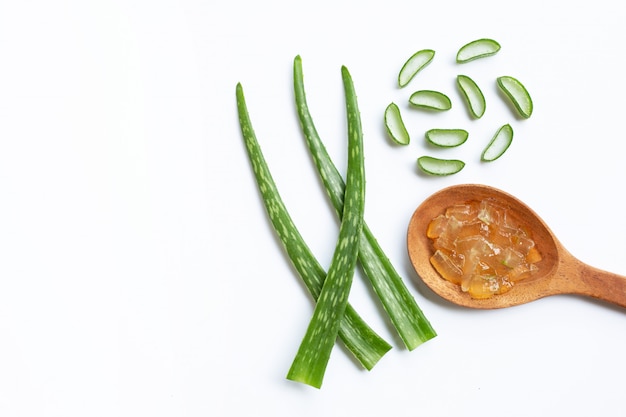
[407,184,626,309]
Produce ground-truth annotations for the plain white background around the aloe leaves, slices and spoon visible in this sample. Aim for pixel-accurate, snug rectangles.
[0,0,626,417]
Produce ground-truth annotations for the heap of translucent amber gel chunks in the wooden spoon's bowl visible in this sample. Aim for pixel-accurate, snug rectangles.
[426,200,541,298]
